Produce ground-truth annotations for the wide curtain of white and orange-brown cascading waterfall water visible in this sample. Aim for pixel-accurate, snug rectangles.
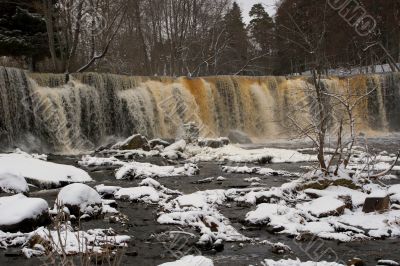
[0,67,400,151]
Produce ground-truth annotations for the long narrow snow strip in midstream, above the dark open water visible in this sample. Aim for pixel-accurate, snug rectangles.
[115,162,198,179]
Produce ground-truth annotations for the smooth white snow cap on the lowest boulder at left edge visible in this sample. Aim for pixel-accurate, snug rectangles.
[0,194,49,226]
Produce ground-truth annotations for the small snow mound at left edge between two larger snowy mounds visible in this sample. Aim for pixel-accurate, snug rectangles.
[0,168,29,193]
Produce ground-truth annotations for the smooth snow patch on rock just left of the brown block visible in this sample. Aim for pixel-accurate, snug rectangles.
[297,196,344,217]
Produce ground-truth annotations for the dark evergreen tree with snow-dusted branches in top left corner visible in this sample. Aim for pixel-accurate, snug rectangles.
[0,0,48,70]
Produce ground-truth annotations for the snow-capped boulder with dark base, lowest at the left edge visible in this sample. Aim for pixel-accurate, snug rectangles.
[0,194,51,232]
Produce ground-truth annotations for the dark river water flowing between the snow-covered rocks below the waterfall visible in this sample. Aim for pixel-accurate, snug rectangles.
[0,139,400,266]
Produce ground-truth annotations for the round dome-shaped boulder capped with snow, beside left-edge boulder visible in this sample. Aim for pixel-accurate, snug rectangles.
[55,183,102,218]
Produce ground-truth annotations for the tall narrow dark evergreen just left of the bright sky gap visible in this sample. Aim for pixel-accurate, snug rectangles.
[222,2,248,74]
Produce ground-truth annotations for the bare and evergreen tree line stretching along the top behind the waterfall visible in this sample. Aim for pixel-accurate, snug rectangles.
[0,0,400,77]
